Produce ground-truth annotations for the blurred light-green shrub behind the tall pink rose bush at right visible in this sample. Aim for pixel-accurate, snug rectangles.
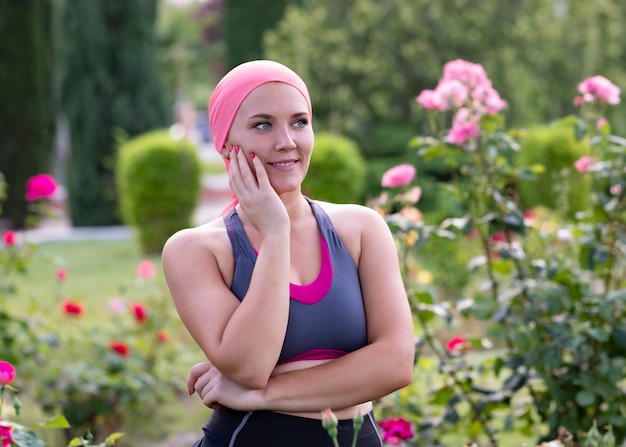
[516,125,590,216]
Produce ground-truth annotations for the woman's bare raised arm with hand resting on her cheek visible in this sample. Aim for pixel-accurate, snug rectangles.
[163,151,289,389]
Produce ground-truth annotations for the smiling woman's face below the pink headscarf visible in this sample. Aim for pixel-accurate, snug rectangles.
[226,82,314,194]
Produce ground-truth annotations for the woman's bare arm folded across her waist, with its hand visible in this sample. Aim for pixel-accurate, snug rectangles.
[188,206,414,412]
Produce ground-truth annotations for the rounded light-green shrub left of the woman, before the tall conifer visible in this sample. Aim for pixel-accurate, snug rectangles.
[116,130,201,254]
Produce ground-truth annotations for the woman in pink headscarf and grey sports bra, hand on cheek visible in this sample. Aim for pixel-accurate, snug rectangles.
[163,61,414,447]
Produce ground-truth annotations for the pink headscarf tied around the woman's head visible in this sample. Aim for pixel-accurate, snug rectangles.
[209,60,313,216]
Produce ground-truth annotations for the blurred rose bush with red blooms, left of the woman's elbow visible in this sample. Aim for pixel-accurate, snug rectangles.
[24,259,182,439]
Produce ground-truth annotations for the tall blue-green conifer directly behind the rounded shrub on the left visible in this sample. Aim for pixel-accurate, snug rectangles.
[61,0,168,226]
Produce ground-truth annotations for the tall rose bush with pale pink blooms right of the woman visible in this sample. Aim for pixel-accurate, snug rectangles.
[373,60,626,446]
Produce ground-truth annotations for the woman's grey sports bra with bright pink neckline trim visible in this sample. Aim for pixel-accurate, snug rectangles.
[224,199,367,364]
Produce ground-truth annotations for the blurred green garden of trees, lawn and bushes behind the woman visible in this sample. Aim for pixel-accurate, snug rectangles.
[0,0,626,446]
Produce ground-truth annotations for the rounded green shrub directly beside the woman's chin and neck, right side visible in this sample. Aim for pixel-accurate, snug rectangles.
[302,133,366,203]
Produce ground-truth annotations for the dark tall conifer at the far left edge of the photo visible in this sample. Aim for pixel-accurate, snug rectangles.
[0,0,55,228]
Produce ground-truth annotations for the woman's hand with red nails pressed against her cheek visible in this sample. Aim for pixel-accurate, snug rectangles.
[229,146,290,238]
